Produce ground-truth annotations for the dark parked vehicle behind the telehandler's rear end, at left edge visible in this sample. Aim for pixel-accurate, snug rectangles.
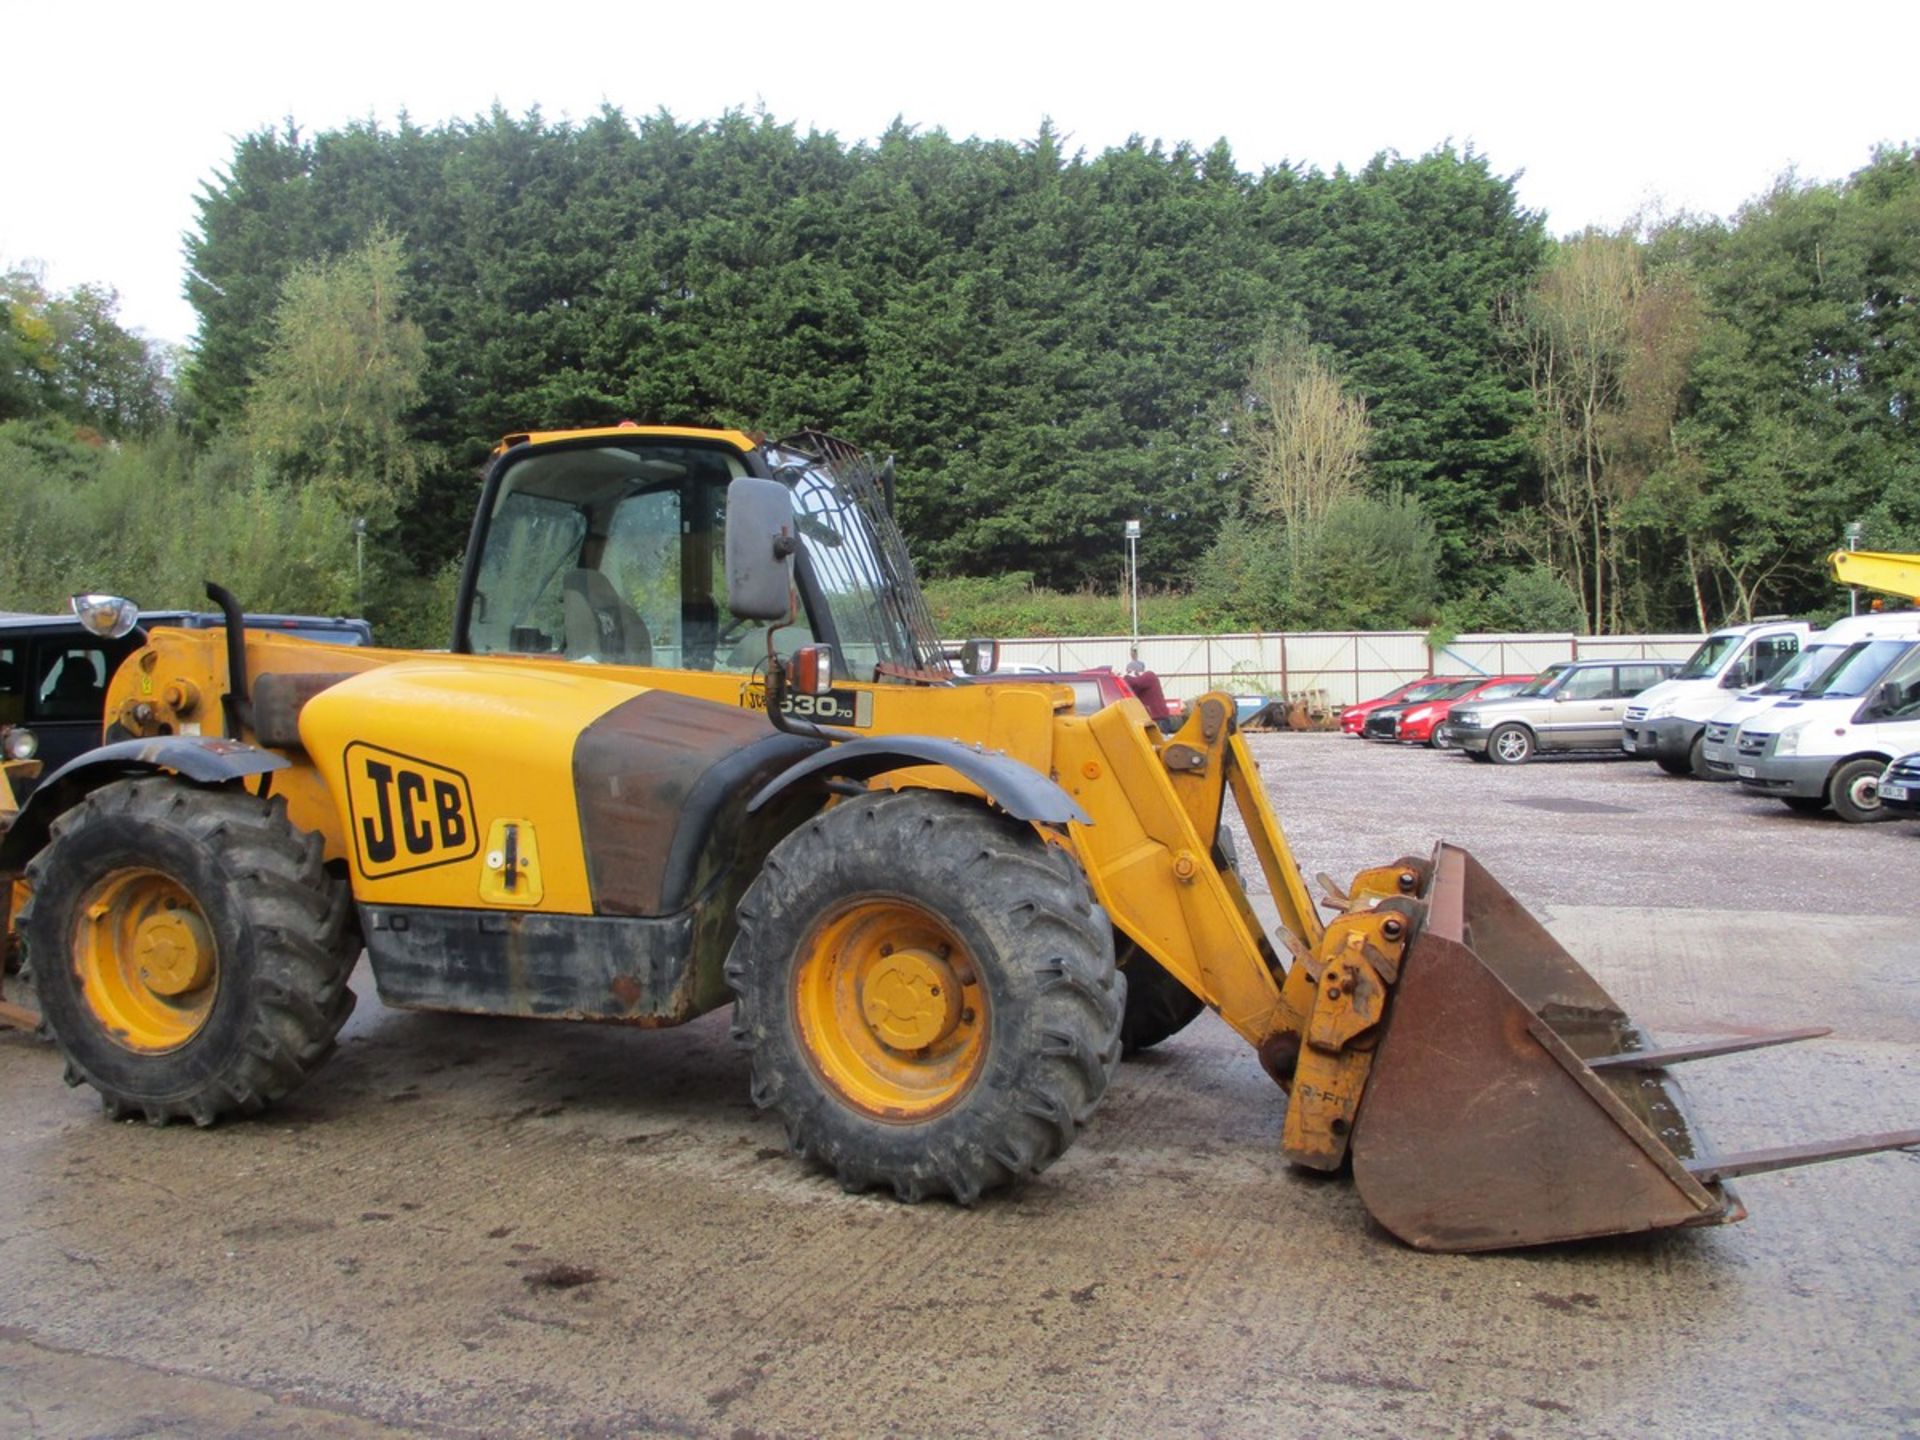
[0,611,372,801]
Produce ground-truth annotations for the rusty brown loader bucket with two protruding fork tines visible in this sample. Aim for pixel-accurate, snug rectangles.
[1352,845,1920,1250]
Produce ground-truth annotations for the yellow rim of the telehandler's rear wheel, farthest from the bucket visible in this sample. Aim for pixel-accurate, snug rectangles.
[73,870,221,1054]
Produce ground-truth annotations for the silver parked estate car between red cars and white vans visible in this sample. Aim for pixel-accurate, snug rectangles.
[1448,660,1680,764]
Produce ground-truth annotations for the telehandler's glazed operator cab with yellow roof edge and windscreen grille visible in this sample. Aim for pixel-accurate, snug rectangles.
[453,426,947,680]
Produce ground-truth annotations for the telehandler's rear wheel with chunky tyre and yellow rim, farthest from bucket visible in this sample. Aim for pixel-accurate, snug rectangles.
[21,778,359,1125]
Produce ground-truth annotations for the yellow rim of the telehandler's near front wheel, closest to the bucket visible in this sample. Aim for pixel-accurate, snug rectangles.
[793,900,987,1119]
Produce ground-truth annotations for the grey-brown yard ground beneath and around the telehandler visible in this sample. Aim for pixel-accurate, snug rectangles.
[0,735,1920,1438]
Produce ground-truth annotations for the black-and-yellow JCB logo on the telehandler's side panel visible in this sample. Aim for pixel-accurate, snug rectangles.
[346,741,480,879]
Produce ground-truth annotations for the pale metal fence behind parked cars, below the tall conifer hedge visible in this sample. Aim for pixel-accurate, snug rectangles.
[1000,630,1701,705]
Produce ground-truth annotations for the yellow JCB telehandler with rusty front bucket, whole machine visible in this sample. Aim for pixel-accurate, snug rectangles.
[0,424,1920,1250]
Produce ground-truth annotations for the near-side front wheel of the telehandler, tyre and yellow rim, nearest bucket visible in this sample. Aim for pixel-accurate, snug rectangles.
[726,791,1127,1204]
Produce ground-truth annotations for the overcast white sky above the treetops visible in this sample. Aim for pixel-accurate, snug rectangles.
[0,0,1920,342]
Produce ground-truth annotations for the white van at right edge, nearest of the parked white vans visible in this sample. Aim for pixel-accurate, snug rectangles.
[1734,637,1920,822]
